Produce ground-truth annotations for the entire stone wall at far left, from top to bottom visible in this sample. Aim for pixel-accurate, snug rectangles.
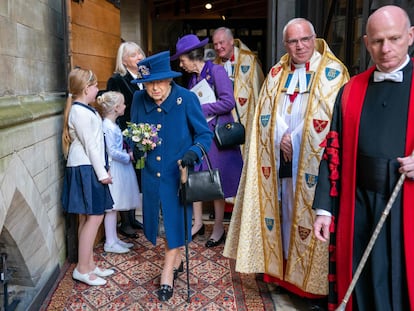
[0,0,67,310]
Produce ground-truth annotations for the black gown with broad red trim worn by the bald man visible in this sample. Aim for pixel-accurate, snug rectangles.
[313,62,414,311]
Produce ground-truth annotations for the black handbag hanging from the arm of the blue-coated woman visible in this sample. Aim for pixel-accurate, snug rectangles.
[180,143,224,204]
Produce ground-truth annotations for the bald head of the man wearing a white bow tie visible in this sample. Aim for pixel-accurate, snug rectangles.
[364,5,414,72]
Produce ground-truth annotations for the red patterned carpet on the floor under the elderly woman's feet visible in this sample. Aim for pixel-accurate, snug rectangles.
[41,226,276,311]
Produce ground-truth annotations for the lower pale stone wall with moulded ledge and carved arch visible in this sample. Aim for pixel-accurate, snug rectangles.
[0,95,66,310]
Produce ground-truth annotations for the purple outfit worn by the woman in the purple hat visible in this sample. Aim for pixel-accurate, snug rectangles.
[188,61,243,198]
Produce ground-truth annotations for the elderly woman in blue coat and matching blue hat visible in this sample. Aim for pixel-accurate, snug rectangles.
[131,51,213,301]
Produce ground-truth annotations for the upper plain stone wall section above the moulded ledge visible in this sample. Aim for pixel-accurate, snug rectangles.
[0,0,66,97]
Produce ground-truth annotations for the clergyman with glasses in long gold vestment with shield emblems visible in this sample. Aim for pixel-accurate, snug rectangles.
[224,18,349,298]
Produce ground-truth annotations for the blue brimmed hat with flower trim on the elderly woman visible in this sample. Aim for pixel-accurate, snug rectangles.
[131,51,182,83]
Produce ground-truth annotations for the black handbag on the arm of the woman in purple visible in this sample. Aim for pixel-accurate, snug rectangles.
[214,104,246,149]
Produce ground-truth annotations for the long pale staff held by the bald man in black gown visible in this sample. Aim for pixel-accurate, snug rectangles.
[335,151,414,311]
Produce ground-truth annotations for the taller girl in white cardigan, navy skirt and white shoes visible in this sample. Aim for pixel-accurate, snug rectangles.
[62,68,114,285]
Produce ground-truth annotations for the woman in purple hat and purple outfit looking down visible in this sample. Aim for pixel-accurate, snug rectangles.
[171,34,243,247]
